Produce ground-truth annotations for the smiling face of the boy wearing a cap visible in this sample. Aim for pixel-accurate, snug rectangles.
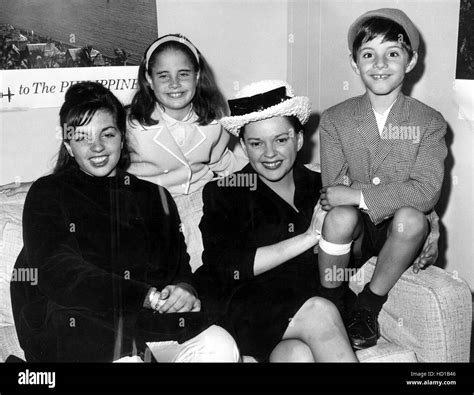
[351,36,417,101]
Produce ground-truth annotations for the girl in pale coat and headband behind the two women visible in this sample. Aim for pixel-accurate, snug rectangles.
[128,34,242,271]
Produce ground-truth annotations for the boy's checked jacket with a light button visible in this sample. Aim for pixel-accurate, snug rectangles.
[320,94,447,224]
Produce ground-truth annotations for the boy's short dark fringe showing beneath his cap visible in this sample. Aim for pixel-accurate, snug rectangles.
[352,17,414,61]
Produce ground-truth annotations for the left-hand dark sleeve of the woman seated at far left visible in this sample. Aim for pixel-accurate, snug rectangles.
[23,179,149,312]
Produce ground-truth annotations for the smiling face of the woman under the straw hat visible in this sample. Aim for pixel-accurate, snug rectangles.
[241,117,303,183]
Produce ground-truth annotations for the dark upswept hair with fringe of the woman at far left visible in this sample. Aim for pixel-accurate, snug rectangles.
[53,81,130,173]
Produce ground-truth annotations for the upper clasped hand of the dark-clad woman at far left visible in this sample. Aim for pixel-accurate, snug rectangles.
[157,284,201,313]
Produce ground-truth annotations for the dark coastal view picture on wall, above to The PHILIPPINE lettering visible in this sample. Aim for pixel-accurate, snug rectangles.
[0,0,158,70]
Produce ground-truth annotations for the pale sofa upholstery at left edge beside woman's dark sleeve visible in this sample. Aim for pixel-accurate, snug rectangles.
[0,193,26,327]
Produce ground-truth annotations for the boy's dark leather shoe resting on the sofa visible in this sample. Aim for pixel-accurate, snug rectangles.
[347,308,380,350]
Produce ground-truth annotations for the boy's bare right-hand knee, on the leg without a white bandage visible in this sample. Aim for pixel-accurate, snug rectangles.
[391,207,428,241]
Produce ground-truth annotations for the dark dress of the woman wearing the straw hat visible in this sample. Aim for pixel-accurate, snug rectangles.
[197,165,322,361]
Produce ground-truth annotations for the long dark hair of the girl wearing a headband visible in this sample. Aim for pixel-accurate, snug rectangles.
[129,35,228,126]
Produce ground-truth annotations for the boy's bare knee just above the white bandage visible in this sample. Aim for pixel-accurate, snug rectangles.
[323,206,359,242]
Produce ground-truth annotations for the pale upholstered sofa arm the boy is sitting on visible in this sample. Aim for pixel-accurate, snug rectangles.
[350,257,472,362]
